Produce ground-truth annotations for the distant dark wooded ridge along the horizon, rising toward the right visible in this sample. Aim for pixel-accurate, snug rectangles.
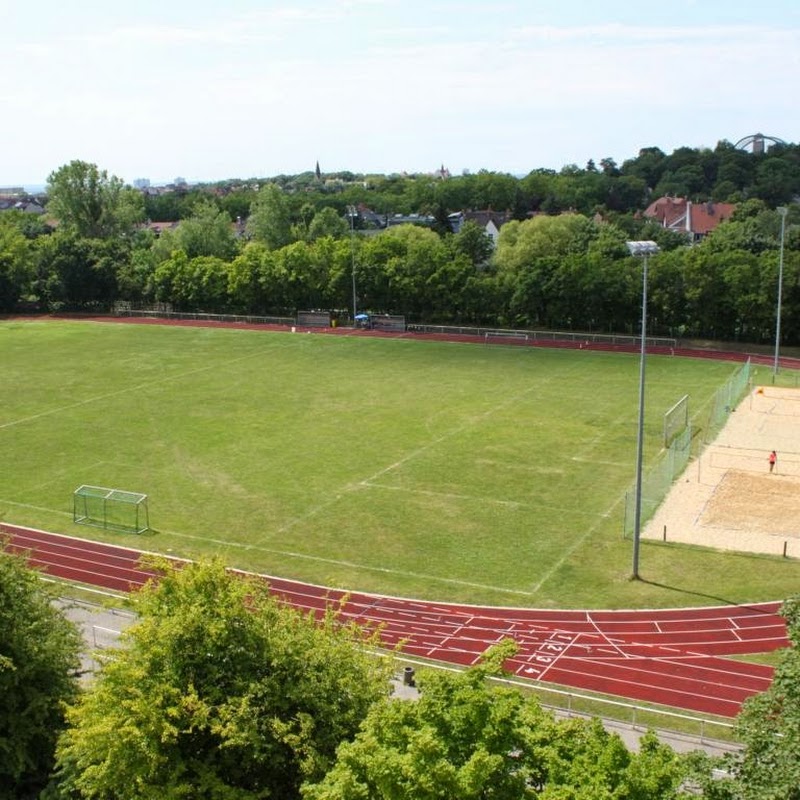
[145,141,800,221]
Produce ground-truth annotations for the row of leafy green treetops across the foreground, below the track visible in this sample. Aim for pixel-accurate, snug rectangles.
[6,552,800,800]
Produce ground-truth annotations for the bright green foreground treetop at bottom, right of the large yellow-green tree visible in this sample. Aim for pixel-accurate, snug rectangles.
[303,642,685,800]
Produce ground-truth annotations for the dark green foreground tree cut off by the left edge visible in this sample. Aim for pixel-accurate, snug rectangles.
[0,552,81,800]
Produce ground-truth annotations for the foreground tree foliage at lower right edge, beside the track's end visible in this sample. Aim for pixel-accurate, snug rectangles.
[729,595,800,800]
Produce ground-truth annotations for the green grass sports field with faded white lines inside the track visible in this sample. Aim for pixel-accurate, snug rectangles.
[0,321,800,607]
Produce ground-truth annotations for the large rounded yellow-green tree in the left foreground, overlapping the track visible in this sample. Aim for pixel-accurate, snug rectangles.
[50,560,387,800]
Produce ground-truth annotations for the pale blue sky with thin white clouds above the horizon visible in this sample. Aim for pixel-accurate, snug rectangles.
[0,0,800,187]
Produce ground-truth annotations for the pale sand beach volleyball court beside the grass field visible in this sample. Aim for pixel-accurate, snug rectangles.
[642,387,800,558]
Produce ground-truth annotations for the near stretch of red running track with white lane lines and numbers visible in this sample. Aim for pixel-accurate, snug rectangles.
[0,524,788,717]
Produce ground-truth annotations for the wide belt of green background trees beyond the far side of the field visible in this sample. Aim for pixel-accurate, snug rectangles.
[0,153,800,344]
